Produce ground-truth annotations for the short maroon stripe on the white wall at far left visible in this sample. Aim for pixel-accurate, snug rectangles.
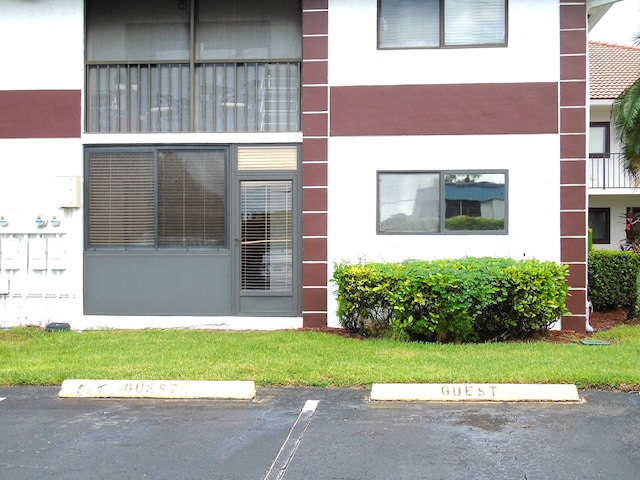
[0,90,82,138]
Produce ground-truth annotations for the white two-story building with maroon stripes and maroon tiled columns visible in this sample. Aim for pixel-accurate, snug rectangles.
[0,0,613,331]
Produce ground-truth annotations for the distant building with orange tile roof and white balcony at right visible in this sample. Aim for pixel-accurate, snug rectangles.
[587,42,640,250]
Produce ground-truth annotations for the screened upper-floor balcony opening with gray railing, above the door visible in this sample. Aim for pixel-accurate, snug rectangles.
[86,0,302,133]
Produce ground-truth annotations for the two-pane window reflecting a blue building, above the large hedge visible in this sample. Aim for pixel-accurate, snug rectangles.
[378,171,507,234]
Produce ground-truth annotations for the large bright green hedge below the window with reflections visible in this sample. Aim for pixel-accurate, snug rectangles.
[333,258,568,342]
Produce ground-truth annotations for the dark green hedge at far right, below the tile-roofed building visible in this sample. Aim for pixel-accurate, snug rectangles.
[588,250,640,311]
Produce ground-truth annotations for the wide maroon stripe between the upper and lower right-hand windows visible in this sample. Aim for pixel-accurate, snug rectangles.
[330,83,558,136]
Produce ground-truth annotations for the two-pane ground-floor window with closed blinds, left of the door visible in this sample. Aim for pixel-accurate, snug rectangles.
[87,148,227,248]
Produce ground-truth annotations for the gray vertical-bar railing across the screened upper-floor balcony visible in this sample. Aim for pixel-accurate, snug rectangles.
[86,62,300,133]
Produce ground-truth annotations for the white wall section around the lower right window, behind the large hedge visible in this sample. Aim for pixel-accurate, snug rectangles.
[328,135,560,325]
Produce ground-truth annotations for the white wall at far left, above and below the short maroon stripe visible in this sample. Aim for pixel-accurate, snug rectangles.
[0,0,84,327]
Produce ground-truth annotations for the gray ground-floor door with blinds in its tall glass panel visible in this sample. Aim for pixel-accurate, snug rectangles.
[237,177,299,316]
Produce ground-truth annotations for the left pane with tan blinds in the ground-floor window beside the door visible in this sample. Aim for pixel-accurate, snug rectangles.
[89,151,155,247]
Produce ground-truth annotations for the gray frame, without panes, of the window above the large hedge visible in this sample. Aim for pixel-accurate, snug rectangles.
[376,169,509,235]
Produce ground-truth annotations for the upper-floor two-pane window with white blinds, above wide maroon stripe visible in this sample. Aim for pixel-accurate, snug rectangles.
[378,0,507,48]
